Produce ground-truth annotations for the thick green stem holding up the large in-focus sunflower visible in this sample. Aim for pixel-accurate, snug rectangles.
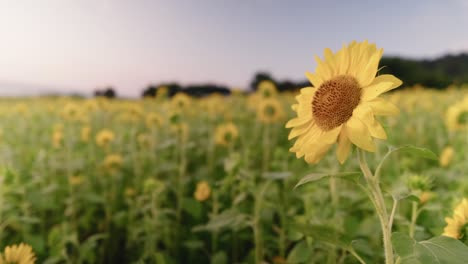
[357,148,394,264]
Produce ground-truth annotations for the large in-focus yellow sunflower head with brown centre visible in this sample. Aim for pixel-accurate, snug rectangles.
[286,41,402,163]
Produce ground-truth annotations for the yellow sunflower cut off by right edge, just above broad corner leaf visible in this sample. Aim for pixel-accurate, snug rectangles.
[442,198,468,239]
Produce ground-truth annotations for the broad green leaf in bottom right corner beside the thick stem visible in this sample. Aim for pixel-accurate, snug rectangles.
[392,233,468,264]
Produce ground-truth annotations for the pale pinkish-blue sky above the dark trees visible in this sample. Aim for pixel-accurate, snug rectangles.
[0,0,468,96]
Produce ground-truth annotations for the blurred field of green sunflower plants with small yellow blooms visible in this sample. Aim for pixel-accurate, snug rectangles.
[0,87,468,264]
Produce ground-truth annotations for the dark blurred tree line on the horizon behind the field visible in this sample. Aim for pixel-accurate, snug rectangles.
[95,53,468,98]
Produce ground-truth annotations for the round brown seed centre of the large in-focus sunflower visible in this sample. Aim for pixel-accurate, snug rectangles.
[312,75,361,131]
